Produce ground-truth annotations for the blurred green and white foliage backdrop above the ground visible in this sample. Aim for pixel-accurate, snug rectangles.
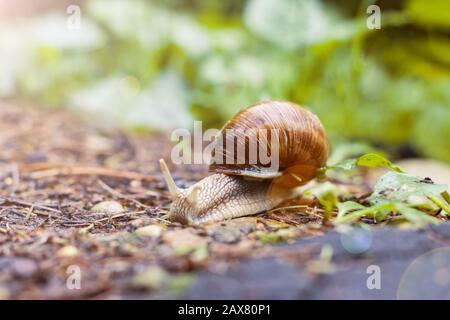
[0,0,450,162]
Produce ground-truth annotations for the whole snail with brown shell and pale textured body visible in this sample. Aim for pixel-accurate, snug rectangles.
[160,101,329,224]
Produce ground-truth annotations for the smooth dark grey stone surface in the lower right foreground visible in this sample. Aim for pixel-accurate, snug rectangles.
[185,225,450,300]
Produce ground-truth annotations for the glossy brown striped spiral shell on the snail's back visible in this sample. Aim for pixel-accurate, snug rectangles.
[209,101,329,187]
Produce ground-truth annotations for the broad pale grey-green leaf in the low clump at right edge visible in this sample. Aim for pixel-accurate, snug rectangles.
[369,172,447,204]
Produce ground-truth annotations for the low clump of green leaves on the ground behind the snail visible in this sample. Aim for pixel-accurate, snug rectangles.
[322,153,450,226]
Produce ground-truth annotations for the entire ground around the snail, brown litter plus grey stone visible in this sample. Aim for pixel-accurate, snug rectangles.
[0,102,450,299]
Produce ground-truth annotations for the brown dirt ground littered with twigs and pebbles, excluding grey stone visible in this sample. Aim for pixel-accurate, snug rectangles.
[0,102,330,299]
